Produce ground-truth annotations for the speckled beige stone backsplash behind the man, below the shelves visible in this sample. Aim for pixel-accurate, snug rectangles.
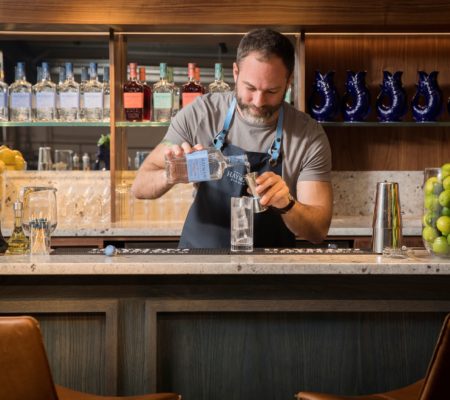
[0,171,423,228]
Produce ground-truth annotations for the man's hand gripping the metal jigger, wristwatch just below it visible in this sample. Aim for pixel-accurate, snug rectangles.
[256,172,289,208]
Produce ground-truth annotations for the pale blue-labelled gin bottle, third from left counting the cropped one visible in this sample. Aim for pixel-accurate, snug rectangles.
[33,62,56,121]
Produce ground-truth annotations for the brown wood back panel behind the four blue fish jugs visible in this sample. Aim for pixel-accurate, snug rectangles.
[305,35,450,170]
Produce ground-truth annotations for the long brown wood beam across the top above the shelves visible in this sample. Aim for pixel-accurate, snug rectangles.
[0,0,450,29]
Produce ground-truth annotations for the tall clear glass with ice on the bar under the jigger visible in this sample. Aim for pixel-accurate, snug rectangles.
[231,196,253,252]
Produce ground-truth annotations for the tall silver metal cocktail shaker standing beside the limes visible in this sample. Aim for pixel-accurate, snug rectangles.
[372,182,403,253]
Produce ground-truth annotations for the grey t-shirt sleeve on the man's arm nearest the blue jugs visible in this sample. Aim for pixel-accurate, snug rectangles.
[298,120,331,181]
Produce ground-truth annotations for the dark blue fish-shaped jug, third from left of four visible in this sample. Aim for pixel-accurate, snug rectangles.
[376,71,408,122]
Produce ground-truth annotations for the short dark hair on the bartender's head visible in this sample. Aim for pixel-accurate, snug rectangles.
[236,28,295,77]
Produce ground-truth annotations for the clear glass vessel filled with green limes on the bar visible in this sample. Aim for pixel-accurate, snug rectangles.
[422,163,450,258]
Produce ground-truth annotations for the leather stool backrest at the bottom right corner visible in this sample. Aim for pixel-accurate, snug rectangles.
[419,314,450,400]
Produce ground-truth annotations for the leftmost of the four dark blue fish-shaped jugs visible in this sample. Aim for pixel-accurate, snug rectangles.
[308,71,339,122]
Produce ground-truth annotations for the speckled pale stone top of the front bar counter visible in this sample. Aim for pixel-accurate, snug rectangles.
[0,249,450,275]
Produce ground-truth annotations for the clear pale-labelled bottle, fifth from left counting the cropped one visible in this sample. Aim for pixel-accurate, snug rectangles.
[83,63,103,122]
